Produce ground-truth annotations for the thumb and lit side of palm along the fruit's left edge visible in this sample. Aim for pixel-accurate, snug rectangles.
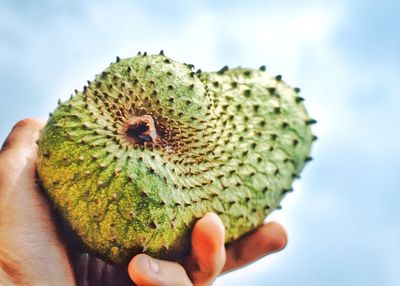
[0,119,75,285]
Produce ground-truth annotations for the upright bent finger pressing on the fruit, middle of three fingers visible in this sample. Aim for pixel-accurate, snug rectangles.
[186,213,226,285]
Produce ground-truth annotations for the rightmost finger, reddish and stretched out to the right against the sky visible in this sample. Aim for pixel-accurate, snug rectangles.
[223,222,287,272]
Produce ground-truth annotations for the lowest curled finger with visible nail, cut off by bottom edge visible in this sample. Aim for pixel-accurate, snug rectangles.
[128,254,192,286]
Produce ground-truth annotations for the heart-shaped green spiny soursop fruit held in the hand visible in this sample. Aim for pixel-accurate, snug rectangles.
[38,53,313,263]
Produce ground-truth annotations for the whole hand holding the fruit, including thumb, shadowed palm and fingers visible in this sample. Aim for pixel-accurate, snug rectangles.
[0,119,287,286]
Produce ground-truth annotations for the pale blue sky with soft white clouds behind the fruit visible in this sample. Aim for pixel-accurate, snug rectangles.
[0,0,400,286]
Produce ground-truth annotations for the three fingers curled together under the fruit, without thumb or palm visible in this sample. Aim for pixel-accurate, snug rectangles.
[128,213,287,286]
